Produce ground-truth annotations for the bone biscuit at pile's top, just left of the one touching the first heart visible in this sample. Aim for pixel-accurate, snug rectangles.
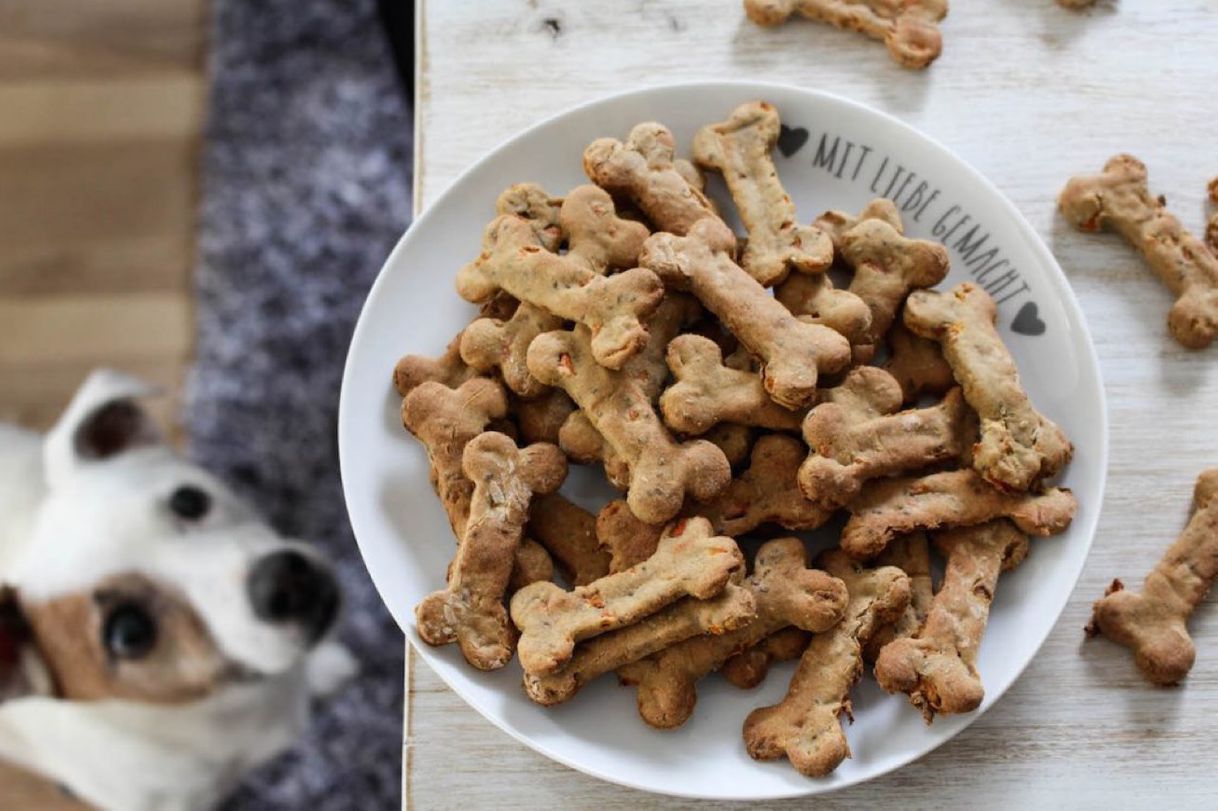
[583,122,716,235]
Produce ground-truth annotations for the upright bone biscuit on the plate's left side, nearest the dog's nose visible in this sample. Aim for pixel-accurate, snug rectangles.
[415,432,566,670]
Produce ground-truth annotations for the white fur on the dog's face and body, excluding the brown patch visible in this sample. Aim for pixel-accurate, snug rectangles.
[0,373,354,811]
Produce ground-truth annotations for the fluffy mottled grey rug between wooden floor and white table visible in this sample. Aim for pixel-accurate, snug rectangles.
[185,0,412,811]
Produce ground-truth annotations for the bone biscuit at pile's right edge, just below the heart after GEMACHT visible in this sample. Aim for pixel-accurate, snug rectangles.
[905,281,1074,491]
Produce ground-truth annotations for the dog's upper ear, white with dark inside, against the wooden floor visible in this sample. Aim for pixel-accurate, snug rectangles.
[43,369,162,487]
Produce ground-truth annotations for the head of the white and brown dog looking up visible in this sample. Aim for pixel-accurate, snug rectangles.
[0,371,339,703]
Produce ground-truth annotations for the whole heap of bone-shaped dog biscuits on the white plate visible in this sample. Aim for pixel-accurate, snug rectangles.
[395,101,1077,776]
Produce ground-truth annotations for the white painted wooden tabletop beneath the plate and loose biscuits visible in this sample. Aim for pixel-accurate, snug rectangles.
[403,0,1218,809]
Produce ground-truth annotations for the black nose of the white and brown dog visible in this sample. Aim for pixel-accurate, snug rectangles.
[246,549,339,642]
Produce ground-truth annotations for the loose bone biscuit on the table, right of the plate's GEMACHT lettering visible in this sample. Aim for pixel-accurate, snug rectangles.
[1057,155,1218,349]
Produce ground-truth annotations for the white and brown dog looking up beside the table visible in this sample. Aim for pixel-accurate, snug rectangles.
[0,371,353,811]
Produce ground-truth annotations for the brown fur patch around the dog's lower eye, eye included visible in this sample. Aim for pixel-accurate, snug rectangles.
[22,574,233,704]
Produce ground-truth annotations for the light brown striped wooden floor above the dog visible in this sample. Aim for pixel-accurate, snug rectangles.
[0,0,207,427]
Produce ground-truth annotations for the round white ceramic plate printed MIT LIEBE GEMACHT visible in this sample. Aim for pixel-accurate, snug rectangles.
[339,82,1107,799]
